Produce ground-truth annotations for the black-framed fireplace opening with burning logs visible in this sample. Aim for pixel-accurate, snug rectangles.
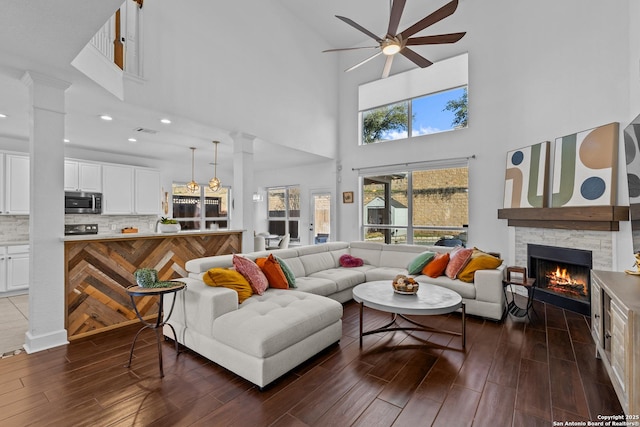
[527,244,592,315]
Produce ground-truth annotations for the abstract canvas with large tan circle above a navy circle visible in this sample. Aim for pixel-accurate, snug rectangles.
[551,123,619,207]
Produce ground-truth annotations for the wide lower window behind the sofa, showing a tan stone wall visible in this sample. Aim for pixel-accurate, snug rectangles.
[361,166,469,246]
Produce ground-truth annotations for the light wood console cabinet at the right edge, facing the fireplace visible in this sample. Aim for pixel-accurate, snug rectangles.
[591,270,640,415]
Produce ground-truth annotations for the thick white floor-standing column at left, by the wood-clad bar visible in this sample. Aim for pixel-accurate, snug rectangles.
[22,72,70,353]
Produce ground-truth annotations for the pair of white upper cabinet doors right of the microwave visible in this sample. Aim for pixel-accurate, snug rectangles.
[102,165,160,215]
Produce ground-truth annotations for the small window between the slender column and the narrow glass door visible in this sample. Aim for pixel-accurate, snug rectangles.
[267,186,300,239]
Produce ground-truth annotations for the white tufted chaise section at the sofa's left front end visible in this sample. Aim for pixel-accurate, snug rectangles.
[165,279,343,387]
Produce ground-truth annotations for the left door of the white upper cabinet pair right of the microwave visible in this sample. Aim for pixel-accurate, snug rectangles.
[102,165,134,215]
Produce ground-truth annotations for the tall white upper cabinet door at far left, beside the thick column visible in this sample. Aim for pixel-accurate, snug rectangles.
[2,154,29,215]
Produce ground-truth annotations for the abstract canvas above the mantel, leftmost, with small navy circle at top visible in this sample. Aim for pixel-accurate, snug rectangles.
[504,141,550,208]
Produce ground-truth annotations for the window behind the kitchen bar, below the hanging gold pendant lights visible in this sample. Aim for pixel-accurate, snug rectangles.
[172,183,230,230]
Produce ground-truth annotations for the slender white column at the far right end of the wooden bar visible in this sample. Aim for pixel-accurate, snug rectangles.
[231,132,256,252]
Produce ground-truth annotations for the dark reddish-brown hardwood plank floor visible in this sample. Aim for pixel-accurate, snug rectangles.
[0,302,622,427]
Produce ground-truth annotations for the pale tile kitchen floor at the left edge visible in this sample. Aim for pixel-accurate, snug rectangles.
[0,295,29,357]
